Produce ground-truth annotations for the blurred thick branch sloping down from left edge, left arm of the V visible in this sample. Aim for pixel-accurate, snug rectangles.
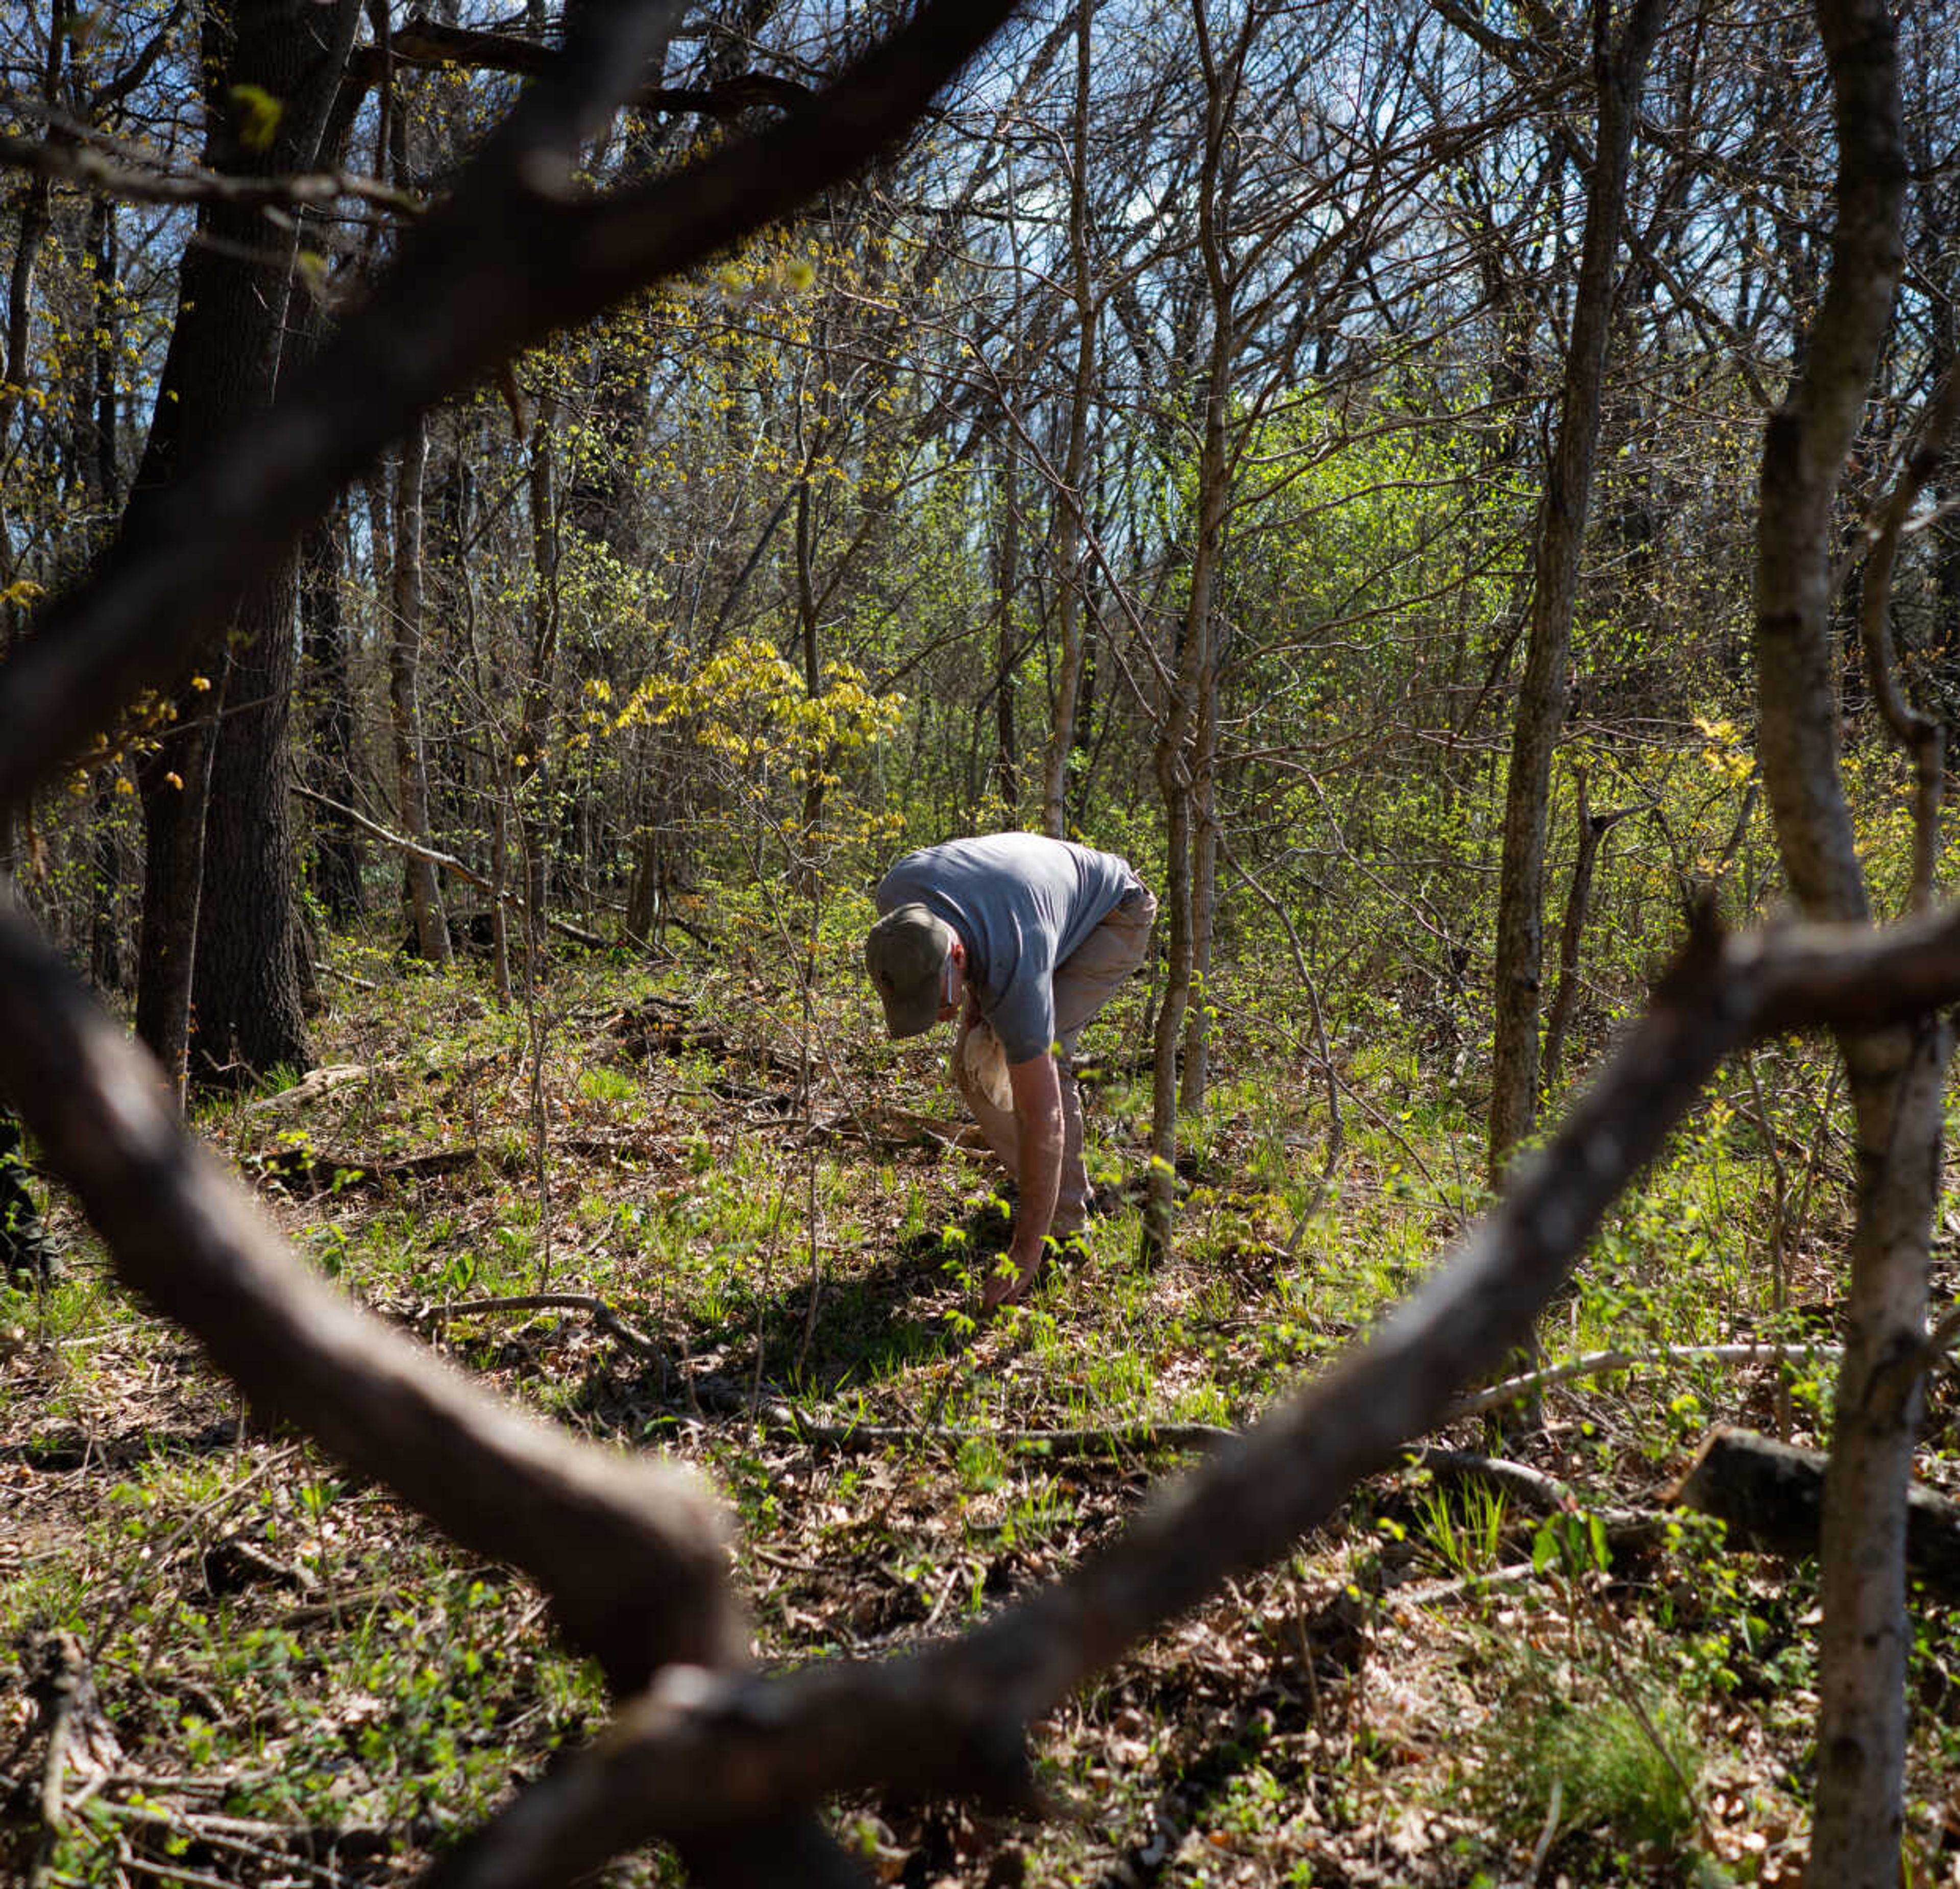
[0,899,745,1689]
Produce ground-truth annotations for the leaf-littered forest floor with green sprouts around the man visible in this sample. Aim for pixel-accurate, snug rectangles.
[0,935,1960,1889]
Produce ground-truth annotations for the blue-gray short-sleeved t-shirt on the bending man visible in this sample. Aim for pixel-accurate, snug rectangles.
[876,833,1139,1062]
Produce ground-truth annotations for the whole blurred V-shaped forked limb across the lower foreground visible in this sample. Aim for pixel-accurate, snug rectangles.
[0,877,1960,1889]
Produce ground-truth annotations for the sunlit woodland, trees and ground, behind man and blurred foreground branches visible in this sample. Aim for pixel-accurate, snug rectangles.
[0,0,1960,1883]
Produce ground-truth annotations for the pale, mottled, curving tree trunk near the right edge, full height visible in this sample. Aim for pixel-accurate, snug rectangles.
[1756,0,1952,1889]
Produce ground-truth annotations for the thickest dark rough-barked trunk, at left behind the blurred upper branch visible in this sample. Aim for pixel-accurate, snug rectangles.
[131,0,359,1082]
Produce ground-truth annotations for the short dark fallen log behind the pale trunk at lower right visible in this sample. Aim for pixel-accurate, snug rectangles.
[1672,1429,1960,1597]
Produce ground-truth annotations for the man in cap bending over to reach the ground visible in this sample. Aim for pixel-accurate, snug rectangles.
[864,833,1157,1307]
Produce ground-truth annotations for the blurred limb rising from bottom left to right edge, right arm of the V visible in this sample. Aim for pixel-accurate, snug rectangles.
[405,915,1960,1889]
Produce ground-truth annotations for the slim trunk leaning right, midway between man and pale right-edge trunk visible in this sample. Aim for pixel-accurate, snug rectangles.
[1489,0,1666,1186]
